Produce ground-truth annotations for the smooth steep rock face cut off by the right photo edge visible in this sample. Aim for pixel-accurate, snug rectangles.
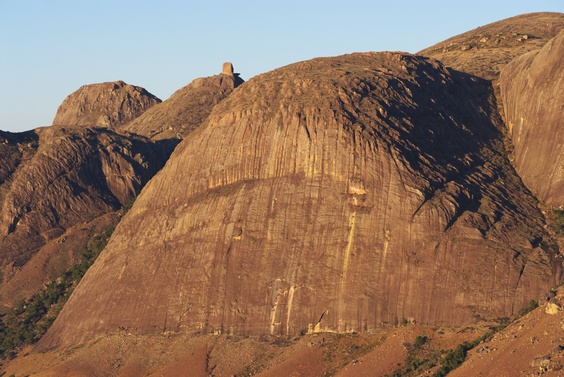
[500,31,564,206]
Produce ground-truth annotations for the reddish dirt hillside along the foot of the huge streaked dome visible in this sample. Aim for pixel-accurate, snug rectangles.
[0,325,490,377]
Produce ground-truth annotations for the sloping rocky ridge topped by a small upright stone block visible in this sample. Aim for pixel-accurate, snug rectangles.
[122,63,243,140]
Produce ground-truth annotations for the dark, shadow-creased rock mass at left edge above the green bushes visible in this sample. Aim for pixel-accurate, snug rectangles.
[0,126,170,304]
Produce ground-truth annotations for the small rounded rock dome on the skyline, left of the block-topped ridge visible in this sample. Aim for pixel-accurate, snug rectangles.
[53,81,161,128]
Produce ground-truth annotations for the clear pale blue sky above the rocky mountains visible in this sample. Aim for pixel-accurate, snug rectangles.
[0,0,564,131]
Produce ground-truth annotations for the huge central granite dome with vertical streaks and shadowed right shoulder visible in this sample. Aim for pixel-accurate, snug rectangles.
[39,53,560,349]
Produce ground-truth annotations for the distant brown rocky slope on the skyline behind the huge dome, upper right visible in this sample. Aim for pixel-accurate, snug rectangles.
[418,12,564,80]
